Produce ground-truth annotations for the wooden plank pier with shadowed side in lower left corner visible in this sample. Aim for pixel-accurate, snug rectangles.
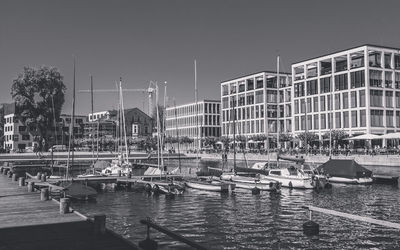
[0,175,139,250]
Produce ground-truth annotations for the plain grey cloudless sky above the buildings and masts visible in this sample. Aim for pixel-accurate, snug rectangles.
[0,0,400,114]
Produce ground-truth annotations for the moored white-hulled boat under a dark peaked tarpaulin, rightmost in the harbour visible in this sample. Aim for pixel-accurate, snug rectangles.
[317,159,373,184]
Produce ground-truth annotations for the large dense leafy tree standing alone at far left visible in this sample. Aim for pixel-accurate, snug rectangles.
[11,66,66,149]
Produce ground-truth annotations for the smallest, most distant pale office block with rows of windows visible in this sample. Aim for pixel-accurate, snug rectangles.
[165,100,221,149]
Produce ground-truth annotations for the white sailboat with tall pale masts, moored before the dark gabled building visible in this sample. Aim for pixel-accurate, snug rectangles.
[101,78,132,176]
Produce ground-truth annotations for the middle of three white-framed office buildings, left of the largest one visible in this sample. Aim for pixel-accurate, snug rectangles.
[221,71,292,147]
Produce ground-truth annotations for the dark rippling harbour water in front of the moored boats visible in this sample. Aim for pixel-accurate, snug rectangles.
[74,161,400,249]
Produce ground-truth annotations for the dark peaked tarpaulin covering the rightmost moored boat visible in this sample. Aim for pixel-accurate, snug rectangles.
[317,159,372,178]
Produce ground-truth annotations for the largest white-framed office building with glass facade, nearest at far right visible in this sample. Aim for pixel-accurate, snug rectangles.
[292,45,400,142]
